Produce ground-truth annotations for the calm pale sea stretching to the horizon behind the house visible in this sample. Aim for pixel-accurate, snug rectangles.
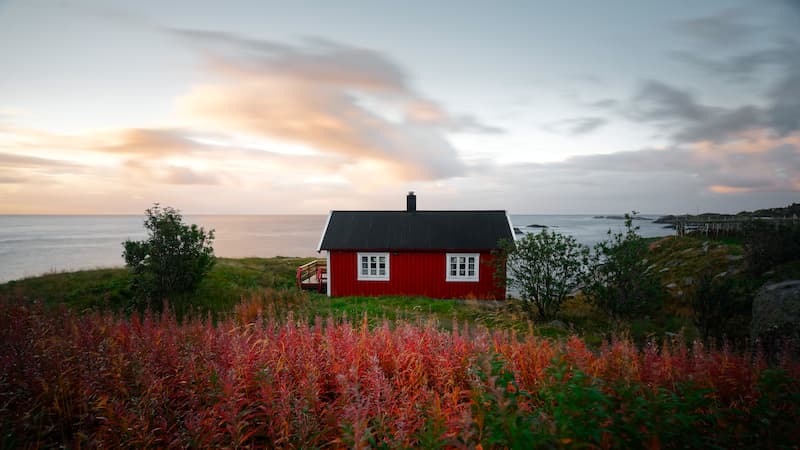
[0,214,674,283]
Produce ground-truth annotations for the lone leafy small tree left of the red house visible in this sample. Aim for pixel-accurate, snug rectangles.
[122,203,216,308]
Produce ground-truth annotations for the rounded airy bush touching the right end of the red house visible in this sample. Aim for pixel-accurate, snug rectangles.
[499,230,589,319]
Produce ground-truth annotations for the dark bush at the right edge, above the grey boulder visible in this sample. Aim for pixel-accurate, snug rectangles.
[745,220,800,275]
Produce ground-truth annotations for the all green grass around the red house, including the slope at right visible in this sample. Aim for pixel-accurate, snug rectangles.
[0,237,764,346]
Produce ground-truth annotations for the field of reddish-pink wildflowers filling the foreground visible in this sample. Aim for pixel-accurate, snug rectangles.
[0,298,800,448]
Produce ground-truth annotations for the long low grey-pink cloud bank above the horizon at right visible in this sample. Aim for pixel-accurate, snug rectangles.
[446,130,800,214]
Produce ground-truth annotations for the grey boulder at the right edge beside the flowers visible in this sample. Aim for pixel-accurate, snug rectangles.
[750,280,800,344]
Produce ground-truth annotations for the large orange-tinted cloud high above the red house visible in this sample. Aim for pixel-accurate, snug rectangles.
[172,30,502,180]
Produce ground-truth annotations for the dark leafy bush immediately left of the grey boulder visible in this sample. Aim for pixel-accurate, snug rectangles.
[692,272,754,344]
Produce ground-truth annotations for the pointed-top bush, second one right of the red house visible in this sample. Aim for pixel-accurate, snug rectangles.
[584,211,665,319]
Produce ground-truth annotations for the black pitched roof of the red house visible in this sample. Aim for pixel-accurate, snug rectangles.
[317,211,514,250]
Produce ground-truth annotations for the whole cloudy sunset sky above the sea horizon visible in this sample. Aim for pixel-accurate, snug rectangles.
[0,0,800,214]
